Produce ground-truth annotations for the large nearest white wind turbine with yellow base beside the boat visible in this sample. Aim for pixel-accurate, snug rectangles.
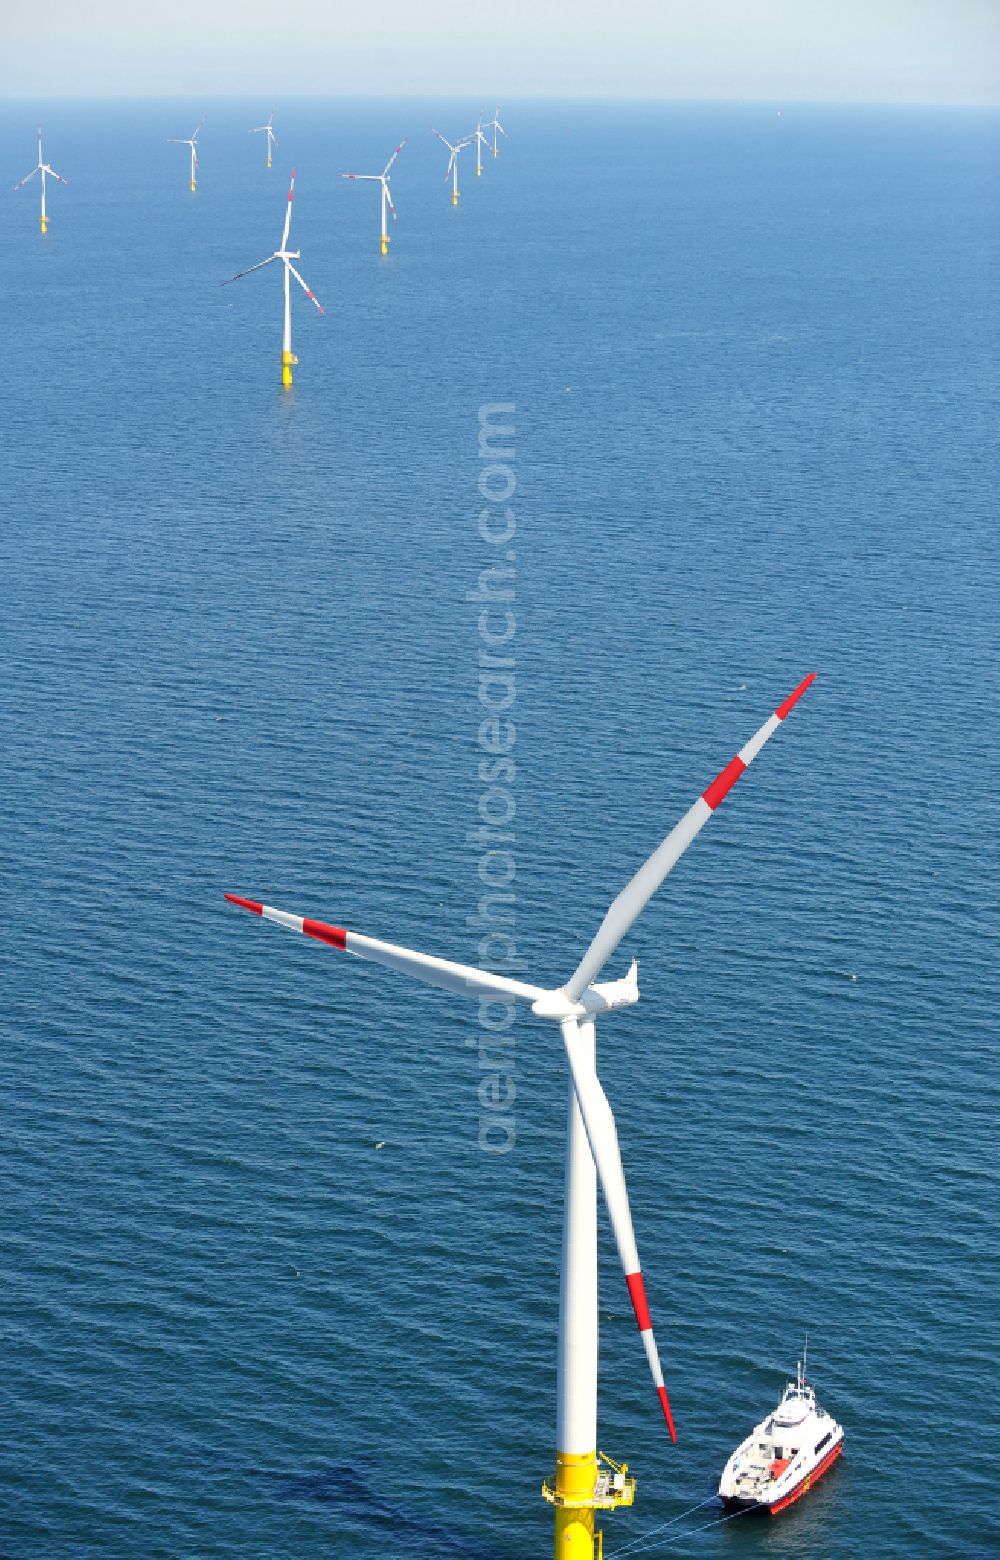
[226,672,816,1560]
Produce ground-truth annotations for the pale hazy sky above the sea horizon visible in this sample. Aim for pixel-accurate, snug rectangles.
[7,0,1000,103]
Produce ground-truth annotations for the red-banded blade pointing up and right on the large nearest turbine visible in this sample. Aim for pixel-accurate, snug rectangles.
[563,672,816,1002]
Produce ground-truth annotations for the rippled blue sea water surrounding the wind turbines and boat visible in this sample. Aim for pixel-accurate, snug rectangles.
[0,101,1000,1560]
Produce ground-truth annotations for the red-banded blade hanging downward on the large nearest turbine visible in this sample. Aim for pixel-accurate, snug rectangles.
[560,1019,677,1441]
